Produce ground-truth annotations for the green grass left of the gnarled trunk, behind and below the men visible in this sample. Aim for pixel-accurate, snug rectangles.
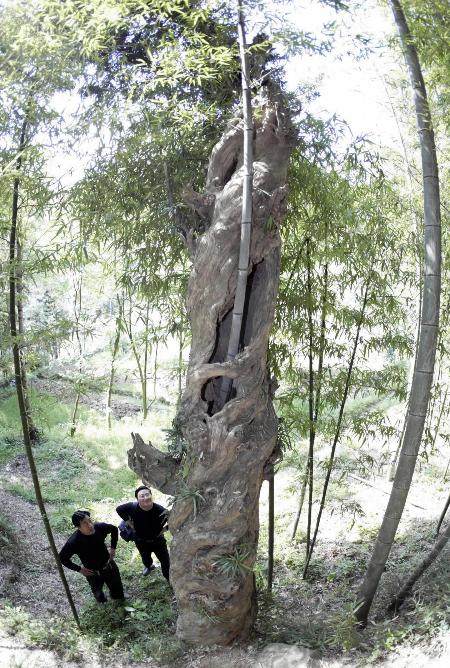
[0,388,180,663]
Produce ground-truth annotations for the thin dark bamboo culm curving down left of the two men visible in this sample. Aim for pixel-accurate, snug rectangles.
[9,113,81,628]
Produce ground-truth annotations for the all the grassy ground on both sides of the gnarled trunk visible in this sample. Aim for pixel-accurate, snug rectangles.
[0,388,449,666]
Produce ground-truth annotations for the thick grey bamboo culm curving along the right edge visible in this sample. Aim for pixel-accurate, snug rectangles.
[356,0,441,626]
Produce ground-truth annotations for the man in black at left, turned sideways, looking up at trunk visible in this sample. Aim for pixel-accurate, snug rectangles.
[59,510,124,603]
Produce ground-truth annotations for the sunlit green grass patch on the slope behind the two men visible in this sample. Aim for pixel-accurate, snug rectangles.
[0,391,171,533]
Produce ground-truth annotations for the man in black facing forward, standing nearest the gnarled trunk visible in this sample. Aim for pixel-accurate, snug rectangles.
[116,485,170,582]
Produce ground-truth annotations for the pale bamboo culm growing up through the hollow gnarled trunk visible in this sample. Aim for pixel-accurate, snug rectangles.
[219,0,253,408]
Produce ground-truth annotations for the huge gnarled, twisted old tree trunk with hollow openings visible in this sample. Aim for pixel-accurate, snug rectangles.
[129,82,295,644]
